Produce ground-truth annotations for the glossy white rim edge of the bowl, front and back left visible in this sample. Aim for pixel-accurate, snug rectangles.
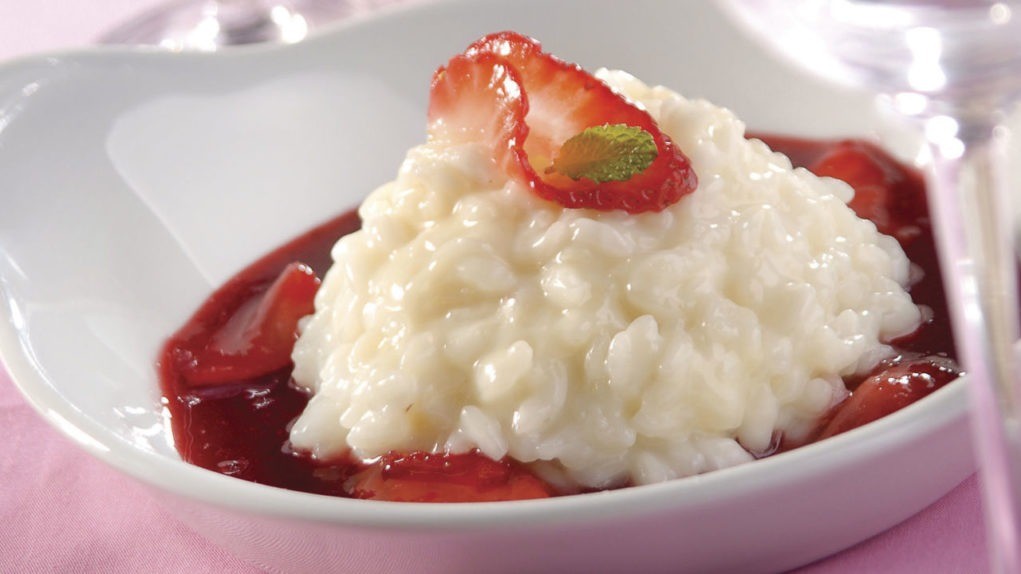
[0,0,967,531]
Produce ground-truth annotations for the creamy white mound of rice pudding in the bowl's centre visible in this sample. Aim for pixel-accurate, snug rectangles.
[290,70,922,488]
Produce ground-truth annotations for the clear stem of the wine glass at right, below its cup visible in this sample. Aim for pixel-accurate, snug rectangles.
[926,116,1021,572]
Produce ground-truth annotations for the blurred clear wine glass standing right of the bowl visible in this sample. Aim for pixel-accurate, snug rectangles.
[722,0,1021,572]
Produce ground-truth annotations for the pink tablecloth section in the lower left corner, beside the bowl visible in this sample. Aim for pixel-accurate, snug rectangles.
[0,371,257,574]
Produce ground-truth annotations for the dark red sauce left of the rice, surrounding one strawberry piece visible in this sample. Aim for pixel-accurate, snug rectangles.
[158,211,360,495]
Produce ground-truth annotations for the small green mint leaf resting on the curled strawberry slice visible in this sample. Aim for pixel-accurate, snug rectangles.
[550,124,659,184]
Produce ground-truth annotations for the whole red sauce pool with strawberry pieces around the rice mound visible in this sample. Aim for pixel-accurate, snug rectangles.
[158,136,960,501]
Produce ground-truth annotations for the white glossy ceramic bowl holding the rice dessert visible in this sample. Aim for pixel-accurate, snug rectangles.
[0,0,973,572]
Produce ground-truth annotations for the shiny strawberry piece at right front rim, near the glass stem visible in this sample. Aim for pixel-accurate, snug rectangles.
[818,356,961,440]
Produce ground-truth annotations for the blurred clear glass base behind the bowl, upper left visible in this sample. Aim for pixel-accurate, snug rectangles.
[99,0,369,51]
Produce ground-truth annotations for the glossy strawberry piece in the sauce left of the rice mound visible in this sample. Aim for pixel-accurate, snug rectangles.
[177,264,320,386]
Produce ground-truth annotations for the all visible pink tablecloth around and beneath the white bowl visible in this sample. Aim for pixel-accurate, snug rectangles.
[0,0,988,574]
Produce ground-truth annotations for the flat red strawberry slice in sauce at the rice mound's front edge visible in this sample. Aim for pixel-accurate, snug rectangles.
[351,451,550,503]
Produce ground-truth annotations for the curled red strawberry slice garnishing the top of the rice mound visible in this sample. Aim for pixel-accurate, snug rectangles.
[429,32,697,213]
